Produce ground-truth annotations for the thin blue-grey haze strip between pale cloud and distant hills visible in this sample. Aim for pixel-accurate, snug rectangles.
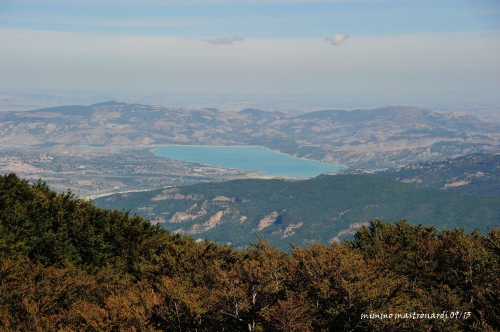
[0,90,500,114]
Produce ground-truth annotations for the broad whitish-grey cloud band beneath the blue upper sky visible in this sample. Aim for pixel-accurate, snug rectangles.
[0,29,500,94]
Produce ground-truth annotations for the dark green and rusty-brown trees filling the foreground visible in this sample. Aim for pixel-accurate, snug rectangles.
[0,174,500,331]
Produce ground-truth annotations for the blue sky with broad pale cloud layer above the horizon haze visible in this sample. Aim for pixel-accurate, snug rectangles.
[0,0,500,108]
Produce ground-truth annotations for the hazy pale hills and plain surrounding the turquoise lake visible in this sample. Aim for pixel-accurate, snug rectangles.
[0,102,500,197]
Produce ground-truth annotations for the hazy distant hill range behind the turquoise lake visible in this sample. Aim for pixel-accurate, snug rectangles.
[0,102,500,168]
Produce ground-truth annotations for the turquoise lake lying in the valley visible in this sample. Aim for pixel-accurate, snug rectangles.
[154,145,344,177]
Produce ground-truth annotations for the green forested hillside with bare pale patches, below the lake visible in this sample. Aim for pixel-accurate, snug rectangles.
[95,175,500,250]
